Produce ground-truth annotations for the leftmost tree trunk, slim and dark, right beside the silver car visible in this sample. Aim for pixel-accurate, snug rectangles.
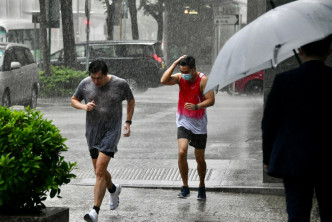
[39,0,51,76]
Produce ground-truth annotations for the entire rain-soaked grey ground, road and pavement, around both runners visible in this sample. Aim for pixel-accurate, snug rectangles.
[20,86,317,221]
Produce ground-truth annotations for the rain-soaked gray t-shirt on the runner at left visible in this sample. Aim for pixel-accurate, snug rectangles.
[74,75,134,153]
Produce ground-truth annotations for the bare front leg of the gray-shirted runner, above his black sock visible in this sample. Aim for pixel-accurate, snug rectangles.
[93,152,112,207]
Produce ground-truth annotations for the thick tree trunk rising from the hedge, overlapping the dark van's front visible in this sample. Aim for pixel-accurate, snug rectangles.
[60,0,76,68]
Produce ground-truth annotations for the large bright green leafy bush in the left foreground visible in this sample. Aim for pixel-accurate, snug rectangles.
[0,106,76,213]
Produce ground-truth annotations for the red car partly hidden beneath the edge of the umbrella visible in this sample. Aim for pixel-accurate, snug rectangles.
[221,70,264,95]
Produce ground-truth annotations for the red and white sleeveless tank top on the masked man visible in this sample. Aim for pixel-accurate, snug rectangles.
[176,73,207,134]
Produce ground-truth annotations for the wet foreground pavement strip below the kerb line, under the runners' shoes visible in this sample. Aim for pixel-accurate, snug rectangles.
[46,185,304,222]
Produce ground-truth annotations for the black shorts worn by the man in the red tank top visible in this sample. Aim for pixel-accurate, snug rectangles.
[178,126,207,149]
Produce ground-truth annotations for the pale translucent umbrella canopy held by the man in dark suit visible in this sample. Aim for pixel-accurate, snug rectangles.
[205,0,332,93]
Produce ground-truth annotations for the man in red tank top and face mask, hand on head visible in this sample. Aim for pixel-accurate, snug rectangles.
[161,56,214,200]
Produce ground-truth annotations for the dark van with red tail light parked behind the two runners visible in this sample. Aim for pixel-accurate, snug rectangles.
[47,40,165,90]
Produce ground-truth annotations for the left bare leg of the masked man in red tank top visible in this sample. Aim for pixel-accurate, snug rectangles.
[178,138,189,187]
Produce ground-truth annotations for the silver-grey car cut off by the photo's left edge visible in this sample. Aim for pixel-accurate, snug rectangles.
[0,43,39,108]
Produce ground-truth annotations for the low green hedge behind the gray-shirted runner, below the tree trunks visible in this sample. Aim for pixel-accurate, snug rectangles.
[39,66,87,97]
